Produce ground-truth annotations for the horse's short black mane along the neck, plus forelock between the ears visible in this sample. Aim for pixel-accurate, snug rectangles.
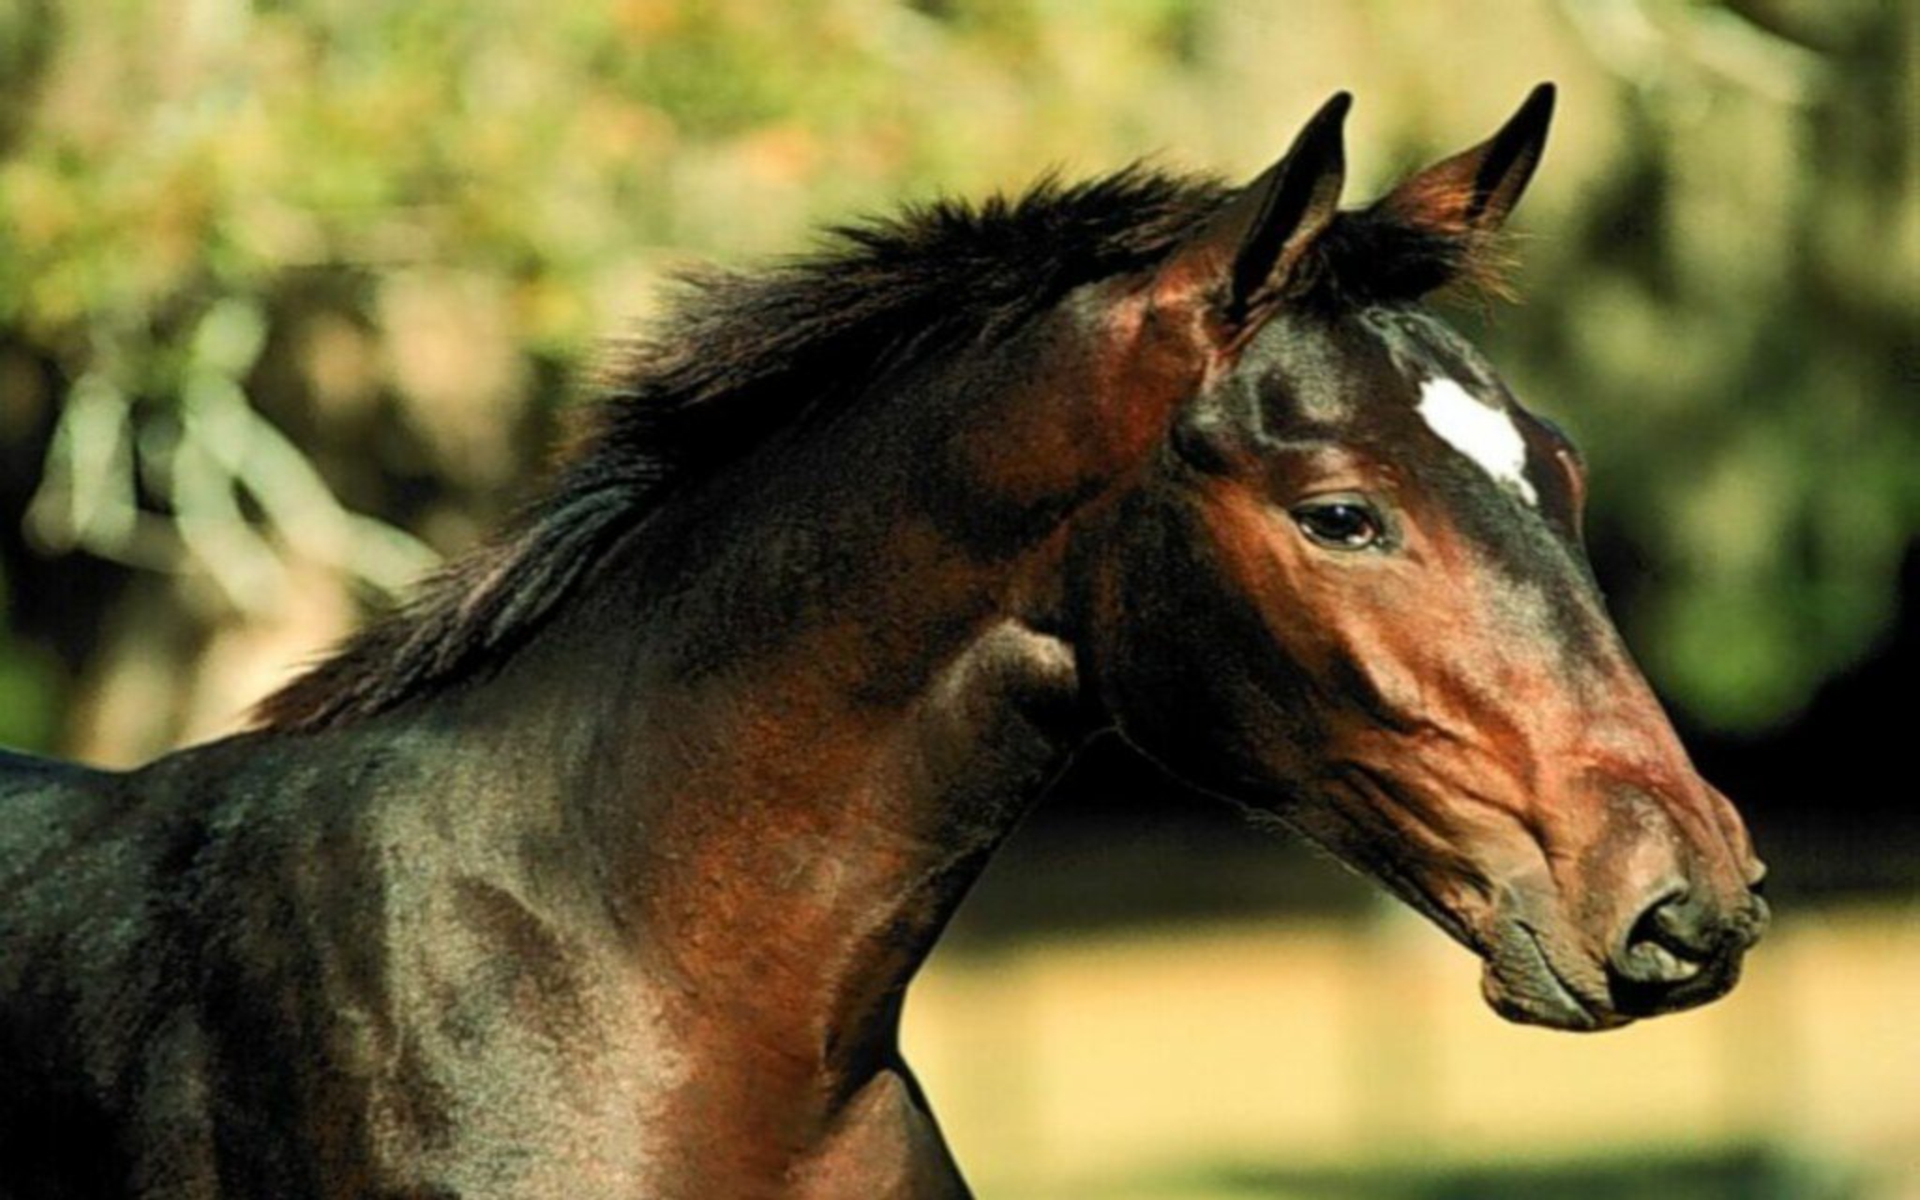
[255,165,1484,730]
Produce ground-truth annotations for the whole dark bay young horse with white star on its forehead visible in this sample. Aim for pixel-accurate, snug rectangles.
[0,84,1768,1198]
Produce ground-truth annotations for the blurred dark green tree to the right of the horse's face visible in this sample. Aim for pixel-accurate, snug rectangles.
[1517,2,1920,726]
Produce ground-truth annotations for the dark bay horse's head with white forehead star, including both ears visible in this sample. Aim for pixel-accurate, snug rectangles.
[1071,86,1766,1029]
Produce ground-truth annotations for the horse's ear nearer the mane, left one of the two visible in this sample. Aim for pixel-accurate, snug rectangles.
[1162,92,1354,323]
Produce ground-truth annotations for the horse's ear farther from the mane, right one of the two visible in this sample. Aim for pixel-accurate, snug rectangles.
[1380,83,1553,232]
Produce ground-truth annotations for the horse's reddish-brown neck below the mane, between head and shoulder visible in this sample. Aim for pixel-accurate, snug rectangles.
[439,320,1152,1079]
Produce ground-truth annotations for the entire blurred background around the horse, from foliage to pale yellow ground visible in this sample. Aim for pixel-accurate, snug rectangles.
[0,0,1920,1200]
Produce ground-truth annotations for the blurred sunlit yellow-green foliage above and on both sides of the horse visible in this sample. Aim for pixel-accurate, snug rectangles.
[0,0,1920,737]
